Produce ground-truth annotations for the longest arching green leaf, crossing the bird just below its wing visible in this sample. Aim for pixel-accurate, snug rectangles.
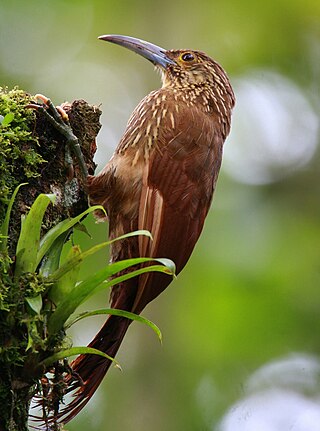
[48,257,174,334]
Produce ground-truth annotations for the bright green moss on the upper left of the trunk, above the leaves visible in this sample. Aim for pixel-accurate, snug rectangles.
[0,87,45,222]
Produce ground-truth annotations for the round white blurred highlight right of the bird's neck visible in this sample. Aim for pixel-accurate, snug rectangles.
[223,70,319,184]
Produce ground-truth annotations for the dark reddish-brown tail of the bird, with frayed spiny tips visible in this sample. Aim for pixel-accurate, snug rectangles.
[58,316,132,424]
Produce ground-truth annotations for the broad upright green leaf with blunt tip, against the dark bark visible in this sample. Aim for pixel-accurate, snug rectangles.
[14,194,55,278]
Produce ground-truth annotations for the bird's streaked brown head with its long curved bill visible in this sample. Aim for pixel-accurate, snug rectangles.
[99,35,234,108]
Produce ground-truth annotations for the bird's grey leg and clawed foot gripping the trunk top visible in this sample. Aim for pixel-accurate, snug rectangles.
[27,94,88,181]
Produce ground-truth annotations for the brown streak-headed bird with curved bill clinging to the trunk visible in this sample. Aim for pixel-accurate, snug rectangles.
[59,35,235,423]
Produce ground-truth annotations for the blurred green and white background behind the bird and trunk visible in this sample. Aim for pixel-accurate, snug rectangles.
[0,0,320,431]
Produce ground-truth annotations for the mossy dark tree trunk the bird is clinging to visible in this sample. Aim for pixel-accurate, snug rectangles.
[0,88,101,431]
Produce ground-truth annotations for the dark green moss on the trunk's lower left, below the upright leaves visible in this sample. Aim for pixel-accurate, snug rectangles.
[0,269,65,431]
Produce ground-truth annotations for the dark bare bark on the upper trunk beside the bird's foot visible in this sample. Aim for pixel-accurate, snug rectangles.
[0,96,101,250]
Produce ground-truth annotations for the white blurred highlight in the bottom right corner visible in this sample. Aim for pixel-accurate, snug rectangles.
[218,354,320,431]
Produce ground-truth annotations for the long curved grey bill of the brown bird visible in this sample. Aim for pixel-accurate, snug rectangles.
[98,34,176,68]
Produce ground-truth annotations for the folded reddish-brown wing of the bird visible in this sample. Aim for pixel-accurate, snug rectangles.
[133,106,222,313]
